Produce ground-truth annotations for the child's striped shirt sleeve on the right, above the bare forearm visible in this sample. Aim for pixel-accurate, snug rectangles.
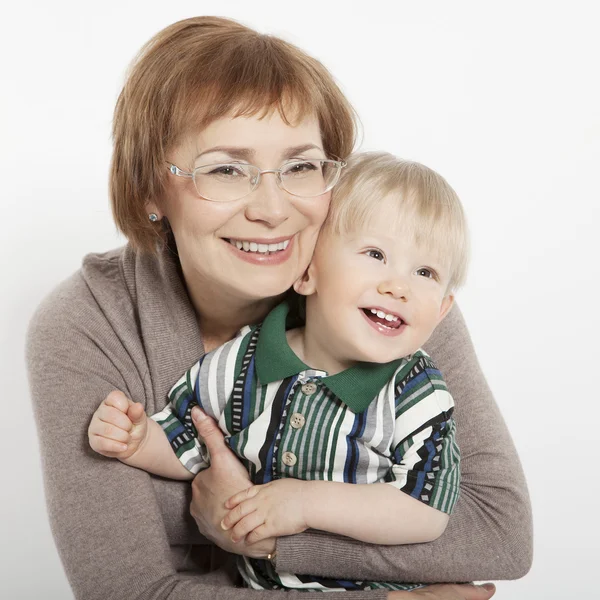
[385,351,460,514]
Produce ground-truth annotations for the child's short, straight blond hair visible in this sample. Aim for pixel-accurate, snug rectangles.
[325,152,469,291]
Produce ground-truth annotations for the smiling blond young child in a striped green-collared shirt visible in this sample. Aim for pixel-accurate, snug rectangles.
[90,153,468,590]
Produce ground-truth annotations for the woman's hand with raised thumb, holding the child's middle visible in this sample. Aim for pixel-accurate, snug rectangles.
[190,407,275,558]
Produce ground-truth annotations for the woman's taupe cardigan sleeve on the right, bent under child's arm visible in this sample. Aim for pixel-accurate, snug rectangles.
[277,306,533,583]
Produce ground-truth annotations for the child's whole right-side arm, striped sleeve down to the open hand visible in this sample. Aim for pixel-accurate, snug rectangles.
[222,353,460,545]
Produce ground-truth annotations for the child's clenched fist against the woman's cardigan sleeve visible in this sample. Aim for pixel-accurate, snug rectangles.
[88,391,148,460]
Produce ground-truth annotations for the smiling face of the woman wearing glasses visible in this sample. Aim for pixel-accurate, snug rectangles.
[151,111,330,301]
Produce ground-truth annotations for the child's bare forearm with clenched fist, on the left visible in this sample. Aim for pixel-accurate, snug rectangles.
[88,392,193,480]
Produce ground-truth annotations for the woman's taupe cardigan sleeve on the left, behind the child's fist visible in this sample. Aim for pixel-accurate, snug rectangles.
[27,276,385,600]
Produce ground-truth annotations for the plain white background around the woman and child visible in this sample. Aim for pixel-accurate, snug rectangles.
[0,0,600,600]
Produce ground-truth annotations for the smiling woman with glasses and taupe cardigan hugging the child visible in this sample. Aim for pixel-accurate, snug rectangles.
[28,18,531,600]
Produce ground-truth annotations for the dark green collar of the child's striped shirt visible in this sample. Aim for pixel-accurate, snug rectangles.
[256,301,402,413]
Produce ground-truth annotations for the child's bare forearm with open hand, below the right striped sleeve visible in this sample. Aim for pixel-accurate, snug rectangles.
[222,478,448,545]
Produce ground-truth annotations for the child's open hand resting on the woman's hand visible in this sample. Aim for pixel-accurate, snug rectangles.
[221,479,308,544]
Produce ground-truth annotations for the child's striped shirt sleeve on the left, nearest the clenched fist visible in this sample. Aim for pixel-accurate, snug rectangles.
[151,359,210,475]
